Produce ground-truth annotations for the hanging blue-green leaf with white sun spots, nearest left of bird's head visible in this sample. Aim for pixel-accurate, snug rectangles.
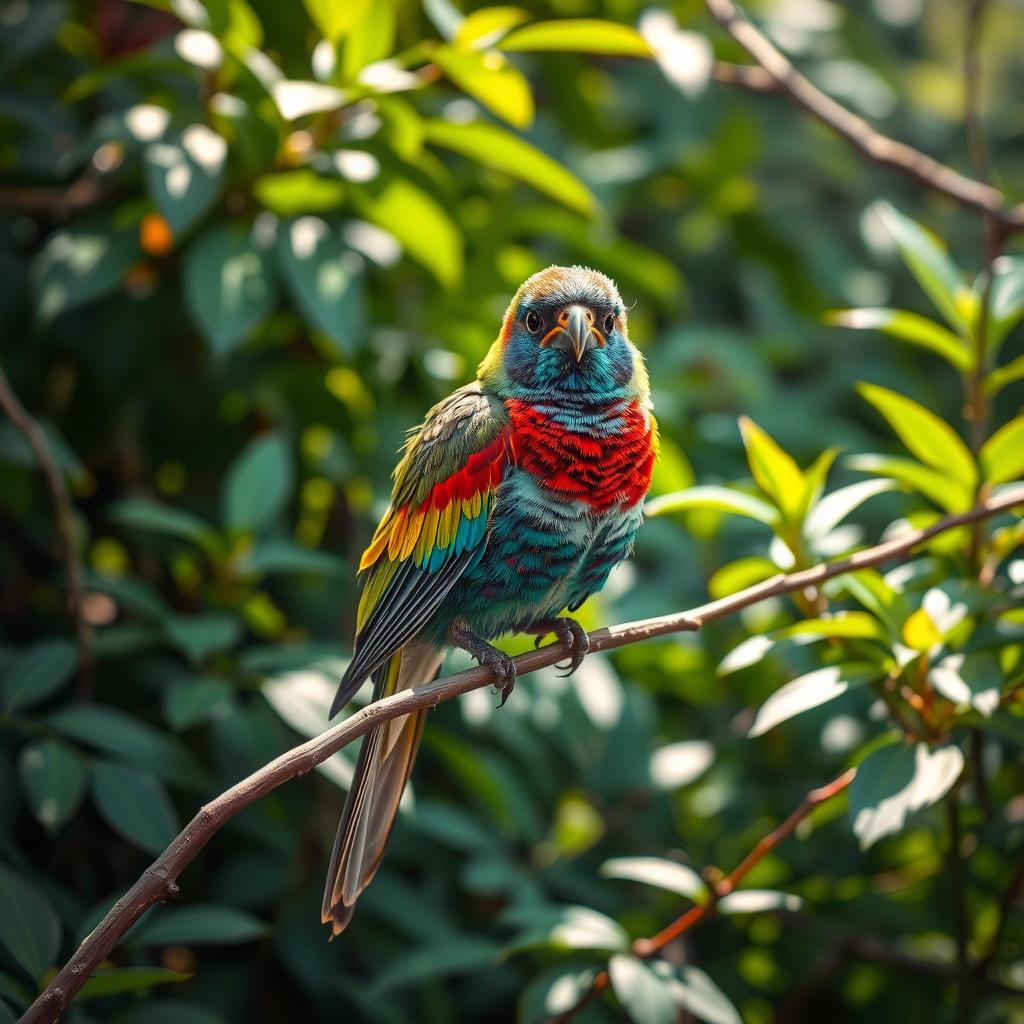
[278,216,365,354]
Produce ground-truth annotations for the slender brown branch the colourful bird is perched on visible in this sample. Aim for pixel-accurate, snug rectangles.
[22,487,1024,1024]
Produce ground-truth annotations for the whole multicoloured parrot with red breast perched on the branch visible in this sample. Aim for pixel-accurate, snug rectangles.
[322,266,658,938]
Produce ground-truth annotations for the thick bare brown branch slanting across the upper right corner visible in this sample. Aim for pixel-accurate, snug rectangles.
[706,0,1024,236]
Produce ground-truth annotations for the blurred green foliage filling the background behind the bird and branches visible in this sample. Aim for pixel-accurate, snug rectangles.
[0,0,1024,1024]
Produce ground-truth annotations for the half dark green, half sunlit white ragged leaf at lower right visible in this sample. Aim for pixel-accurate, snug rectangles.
[850,743,964,850]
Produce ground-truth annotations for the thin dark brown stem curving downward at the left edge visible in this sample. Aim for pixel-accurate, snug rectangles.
[0,366,93,696]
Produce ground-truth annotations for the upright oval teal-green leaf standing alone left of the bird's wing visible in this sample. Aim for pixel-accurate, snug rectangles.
[222,433,295,530]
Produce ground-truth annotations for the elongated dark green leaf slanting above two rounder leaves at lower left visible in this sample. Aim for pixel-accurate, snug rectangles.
[47,703,205,787]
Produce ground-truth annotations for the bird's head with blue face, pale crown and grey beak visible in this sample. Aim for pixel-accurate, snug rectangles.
[478,266,647,400]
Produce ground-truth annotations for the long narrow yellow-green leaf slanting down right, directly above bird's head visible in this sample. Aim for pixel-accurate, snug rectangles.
[424,121,594,215]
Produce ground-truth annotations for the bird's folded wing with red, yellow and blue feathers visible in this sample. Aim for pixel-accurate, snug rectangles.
[331,383,509,717]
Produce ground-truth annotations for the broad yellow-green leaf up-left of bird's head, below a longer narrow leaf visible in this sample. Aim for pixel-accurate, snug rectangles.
[354,176,463,288]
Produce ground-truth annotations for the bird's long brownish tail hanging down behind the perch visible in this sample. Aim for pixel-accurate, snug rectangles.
[322,643,444,935]
